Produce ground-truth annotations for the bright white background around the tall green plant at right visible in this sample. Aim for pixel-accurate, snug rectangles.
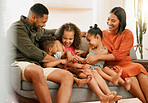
[125,0,148,59]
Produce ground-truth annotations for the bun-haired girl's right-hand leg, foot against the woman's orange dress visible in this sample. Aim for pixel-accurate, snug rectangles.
[102,68,131,91]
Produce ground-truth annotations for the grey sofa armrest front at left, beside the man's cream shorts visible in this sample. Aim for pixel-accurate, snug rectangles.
[10,66,21,93]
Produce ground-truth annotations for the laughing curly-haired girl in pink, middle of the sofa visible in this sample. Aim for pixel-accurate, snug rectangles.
[57,23,121,103]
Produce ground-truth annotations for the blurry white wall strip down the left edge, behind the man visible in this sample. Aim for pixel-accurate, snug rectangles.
[0,0,33,103]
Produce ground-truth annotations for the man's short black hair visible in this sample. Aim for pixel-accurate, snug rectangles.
[30,3,49,17]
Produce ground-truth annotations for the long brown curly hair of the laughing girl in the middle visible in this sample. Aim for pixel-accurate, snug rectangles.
[57,23,81,49]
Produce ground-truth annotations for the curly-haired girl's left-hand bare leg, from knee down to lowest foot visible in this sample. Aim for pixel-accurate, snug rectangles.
[84,69,114,103]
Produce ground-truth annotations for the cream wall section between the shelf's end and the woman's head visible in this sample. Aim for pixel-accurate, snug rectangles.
[94,0,124,30]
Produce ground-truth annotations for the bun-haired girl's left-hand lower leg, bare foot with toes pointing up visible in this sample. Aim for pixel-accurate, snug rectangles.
[96,67,122,85]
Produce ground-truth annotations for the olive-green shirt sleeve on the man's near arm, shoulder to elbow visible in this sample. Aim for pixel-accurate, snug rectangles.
[8,23,47,63]
